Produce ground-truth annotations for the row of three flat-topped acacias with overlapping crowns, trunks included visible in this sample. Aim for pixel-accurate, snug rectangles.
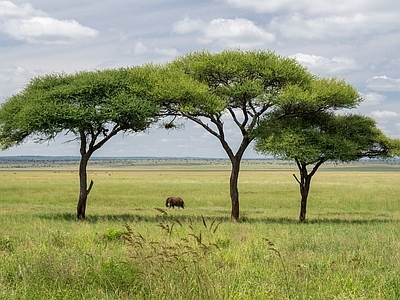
[0,50,400,222]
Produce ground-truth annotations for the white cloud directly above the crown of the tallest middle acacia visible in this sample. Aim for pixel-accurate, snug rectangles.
[173,18,275,49]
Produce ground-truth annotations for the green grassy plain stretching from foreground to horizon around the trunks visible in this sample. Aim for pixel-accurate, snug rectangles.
[0,160,400,299]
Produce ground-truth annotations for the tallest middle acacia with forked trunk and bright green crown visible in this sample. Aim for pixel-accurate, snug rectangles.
[165,50,312,221]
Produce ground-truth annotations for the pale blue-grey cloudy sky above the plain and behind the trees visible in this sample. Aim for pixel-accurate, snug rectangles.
[0,0,400,158]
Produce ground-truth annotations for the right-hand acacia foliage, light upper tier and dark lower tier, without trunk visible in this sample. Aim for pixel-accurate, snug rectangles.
[253,73,398,165]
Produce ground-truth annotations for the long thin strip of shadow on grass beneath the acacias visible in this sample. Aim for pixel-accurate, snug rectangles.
[37,208,400,225]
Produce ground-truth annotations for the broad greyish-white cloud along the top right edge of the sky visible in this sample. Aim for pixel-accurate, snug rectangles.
[220,0,400,43]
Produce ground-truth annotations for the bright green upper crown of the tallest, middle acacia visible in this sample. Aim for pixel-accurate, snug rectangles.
[173,50,311,116]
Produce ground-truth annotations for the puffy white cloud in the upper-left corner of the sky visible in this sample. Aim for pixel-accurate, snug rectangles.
[0,1,99,44]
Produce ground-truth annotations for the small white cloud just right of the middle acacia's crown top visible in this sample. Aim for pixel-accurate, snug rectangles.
[291,53,362,74]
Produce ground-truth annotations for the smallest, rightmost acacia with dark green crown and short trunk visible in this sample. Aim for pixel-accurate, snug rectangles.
[255,112,399,222]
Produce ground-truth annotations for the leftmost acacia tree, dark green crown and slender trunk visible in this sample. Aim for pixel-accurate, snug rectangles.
[0,69,159,219]
